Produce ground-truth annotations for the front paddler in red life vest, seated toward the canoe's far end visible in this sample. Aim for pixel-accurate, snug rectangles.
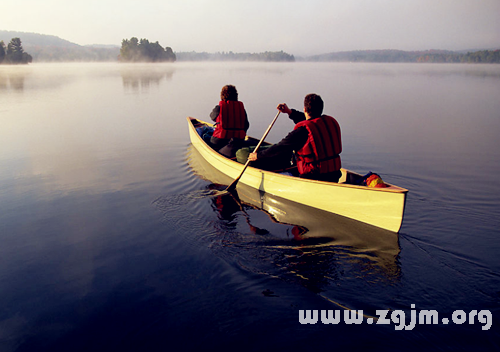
[210,85,250,158]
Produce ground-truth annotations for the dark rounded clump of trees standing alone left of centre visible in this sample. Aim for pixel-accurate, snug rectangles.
[119,37,176,62]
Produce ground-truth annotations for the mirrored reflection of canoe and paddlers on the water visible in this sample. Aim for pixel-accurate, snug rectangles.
[188,146,400,286]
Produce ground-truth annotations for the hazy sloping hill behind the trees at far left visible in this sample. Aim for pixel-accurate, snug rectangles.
[0,30,120,62]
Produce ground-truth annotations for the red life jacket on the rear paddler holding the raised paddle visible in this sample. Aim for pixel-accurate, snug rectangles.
[294,115,342,174]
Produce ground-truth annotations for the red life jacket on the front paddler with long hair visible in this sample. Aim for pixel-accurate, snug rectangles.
[213,101,246,139]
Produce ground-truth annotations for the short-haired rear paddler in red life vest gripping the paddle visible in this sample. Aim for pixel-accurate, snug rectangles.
[248,94,342,182]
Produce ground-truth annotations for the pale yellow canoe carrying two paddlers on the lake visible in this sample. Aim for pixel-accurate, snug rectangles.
[187,117,408,232]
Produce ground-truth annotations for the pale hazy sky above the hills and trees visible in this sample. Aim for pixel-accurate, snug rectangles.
[0,0,500,55]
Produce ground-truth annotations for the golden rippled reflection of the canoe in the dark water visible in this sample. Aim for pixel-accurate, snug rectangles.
[187,145,400,286]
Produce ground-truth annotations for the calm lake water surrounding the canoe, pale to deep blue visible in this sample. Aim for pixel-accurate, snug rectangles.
[0,63,500,352]
